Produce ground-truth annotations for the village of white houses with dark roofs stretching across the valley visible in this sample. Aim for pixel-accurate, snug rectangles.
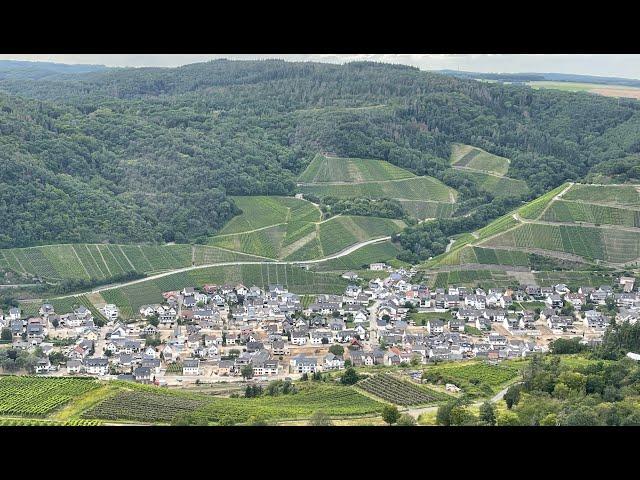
[0,264,640,386]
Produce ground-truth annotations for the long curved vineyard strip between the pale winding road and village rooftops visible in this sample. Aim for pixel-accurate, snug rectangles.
[102,264,348,318]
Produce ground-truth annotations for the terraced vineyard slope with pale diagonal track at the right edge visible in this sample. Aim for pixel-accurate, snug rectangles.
[427,183,640,268]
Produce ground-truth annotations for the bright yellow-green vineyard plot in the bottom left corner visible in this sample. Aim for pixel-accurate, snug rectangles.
[0,376,98,416]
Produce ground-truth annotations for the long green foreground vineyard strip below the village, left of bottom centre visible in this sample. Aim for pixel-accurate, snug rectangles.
[83,385,382,423]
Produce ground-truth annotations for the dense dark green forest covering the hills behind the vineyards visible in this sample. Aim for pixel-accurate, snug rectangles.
[0,60,640,248]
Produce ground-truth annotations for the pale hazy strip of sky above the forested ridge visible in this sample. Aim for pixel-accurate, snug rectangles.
[0,54,640,79]
